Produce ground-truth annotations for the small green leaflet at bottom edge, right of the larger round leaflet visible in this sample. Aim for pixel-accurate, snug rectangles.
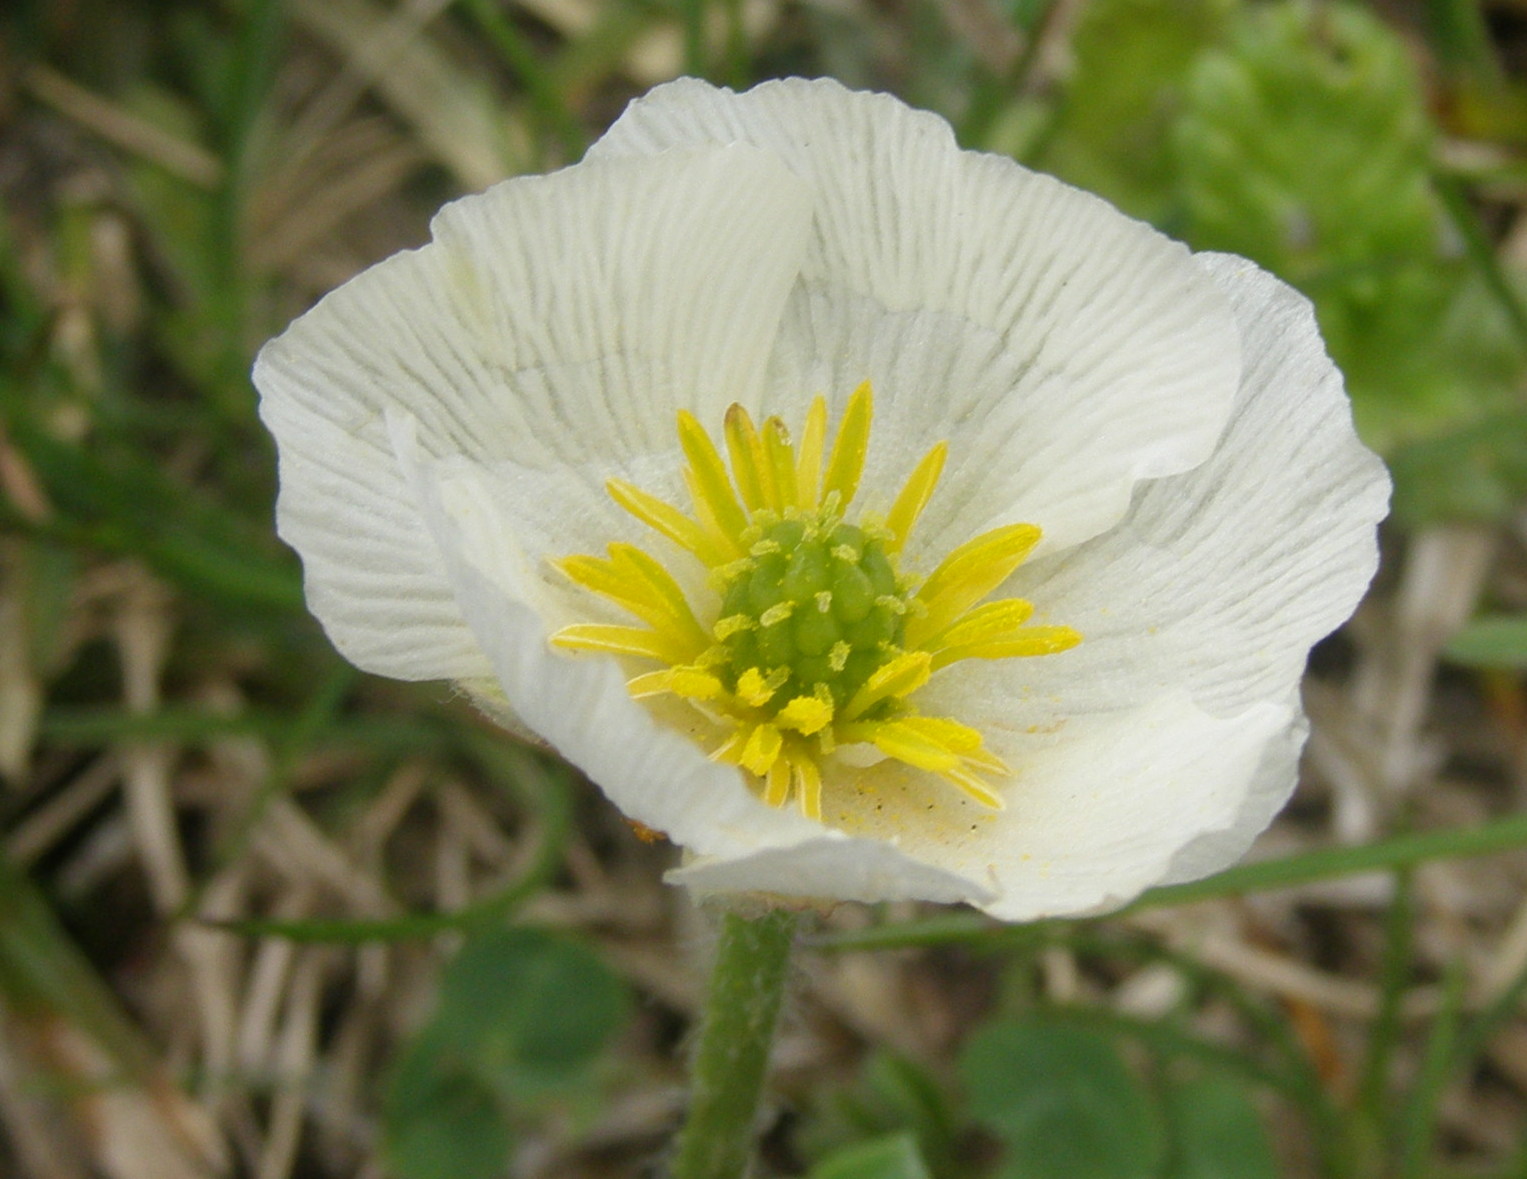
[1167,1074,1278,1179]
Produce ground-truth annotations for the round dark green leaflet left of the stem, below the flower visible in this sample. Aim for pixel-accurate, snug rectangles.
[435,929,626,1097]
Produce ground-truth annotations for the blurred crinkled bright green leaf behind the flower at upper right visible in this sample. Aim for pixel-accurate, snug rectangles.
[1173,0,1522,451]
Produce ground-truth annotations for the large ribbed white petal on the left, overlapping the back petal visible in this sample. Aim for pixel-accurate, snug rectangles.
[255,147,809,680]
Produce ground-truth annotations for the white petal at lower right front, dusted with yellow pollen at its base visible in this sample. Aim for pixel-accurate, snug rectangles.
[812,692,1290,921]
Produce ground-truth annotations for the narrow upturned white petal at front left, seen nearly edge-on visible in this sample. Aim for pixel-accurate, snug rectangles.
[392,415,823,857]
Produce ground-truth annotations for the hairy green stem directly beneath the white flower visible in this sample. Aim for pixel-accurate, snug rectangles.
[670,909,797,1179]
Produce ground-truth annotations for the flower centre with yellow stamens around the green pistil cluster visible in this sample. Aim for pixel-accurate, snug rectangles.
[551,382,1081,819]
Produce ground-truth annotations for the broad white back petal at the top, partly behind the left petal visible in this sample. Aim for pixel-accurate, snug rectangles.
[589,79,1238,548]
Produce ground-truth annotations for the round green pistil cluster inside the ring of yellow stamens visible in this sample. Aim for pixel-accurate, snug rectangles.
[715,512,909,709]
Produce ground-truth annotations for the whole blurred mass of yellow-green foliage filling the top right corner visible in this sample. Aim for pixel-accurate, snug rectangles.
[1031,0,1527,524]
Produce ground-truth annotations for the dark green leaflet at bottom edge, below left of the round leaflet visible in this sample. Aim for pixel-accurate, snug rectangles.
[382,1029,512,1179]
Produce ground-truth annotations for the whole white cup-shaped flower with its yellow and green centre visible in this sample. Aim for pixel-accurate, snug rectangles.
[255,79,1388,919]
